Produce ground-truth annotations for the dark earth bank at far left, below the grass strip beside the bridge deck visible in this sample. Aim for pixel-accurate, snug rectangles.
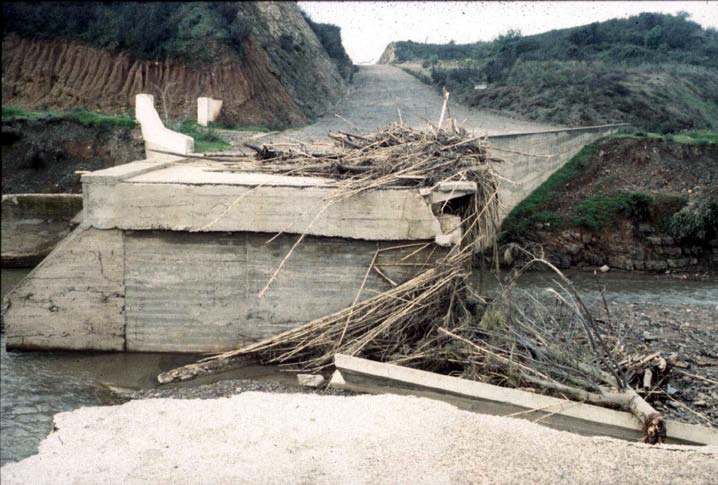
[2,120,145,194]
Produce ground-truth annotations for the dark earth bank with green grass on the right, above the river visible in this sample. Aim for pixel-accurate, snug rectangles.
[502,138,718,271]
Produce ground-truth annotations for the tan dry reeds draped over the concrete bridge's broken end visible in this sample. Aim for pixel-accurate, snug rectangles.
[159,124,498,383]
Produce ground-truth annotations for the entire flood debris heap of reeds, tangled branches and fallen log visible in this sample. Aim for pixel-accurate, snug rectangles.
[158,125,665,442]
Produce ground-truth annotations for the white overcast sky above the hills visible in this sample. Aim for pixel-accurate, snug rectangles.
[298,1,718,64]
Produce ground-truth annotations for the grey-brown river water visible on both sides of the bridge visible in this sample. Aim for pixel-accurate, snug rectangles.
[0,269,718,464]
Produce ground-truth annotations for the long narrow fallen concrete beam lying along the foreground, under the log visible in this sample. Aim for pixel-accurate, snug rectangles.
[330,354,718,445]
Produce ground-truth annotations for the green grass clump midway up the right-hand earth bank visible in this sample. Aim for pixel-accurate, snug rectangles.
[571,192,653,232]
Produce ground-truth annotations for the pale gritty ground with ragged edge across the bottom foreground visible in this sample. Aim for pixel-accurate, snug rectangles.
[0,392,718,485]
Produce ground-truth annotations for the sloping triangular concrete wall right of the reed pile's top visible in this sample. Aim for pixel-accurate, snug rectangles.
[489,124,629,219]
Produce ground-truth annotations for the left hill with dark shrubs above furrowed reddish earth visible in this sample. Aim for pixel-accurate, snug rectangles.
[2,2,352,128]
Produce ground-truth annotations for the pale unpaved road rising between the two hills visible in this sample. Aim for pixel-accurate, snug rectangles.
[223,64,557,147]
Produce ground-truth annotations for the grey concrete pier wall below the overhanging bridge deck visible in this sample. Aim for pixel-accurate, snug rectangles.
[4,227,449,352]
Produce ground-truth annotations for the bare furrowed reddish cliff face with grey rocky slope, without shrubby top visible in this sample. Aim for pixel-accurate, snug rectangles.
[2,2,346,127]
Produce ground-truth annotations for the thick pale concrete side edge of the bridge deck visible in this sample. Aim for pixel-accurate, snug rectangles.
[83,169,442,240]
